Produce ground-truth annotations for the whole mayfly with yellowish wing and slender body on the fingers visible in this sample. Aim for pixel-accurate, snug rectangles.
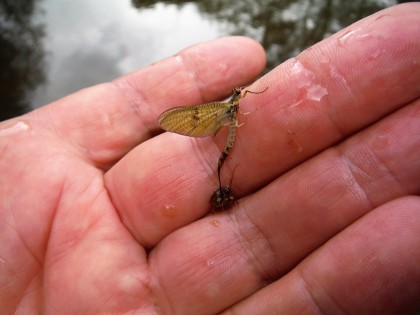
[158,87,267,202]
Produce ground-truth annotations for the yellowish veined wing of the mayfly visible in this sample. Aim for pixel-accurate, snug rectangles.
[158,102,232,138]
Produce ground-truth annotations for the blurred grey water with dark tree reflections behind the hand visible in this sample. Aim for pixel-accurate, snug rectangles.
[0,0,410,120]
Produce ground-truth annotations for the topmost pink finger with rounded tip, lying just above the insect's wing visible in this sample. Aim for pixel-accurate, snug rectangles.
[26,37,265,168]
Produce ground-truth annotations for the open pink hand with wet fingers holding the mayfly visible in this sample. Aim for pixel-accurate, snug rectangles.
[0,3,420,314]
